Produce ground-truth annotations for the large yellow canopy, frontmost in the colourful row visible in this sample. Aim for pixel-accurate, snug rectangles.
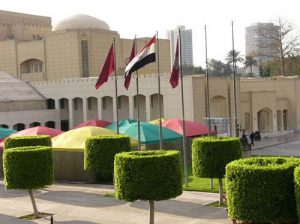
[52,126,137,151]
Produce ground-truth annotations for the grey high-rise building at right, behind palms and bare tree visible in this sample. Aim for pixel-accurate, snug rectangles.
[246,23,280,75]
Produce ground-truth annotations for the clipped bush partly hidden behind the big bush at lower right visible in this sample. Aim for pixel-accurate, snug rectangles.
[192,137,242,178]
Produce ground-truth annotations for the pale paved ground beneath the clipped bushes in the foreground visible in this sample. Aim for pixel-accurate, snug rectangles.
[0,181,231,224]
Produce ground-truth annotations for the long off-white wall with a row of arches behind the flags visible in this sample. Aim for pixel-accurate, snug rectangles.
[28,74,194,129]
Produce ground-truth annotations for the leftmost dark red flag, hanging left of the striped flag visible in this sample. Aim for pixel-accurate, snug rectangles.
[95,44,115,89]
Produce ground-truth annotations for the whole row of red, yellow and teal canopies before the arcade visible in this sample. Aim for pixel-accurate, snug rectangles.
[0,119,214,149]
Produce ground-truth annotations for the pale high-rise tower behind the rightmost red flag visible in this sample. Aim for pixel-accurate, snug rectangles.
[167,26,194,66]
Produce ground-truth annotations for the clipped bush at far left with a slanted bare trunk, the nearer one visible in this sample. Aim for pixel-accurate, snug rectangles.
[3,146,53,190]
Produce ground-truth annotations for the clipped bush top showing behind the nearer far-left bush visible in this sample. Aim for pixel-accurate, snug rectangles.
[4,135,52,149]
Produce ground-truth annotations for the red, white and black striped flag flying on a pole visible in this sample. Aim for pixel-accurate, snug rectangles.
[125,36,156,77]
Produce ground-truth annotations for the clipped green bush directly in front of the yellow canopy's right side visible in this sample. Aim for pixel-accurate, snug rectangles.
[84,135,131,179]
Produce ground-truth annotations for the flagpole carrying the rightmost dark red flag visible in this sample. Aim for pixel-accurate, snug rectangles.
[178,29,188,187]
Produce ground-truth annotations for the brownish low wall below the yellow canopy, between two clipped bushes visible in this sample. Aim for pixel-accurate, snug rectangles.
[53,149,95,183]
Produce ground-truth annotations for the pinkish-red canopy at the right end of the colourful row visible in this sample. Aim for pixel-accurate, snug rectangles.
[162,119,215,137]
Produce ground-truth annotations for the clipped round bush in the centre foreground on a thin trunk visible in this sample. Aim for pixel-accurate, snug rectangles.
[114,150,182,201]
